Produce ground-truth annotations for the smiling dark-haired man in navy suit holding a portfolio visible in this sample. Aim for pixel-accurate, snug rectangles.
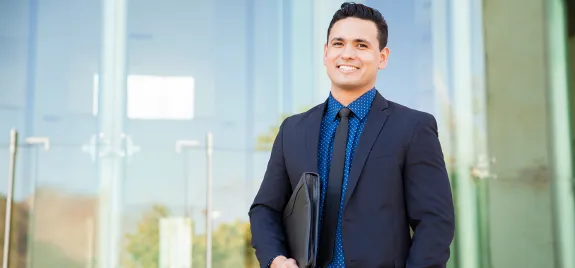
[249,3,455,268]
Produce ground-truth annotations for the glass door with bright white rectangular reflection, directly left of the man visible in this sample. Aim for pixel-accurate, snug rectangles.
[114,0,325,267]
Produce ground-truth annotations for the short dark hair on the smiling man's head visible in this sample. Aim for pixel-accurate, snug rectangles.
[327,2,388,50]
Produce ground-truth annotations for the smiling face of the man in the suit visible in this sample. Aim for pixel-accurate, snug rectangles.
[323,17,389,90]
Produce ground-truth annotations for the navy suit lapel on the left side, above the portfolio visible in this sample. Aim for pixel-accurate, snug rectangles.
[305,101,327,173]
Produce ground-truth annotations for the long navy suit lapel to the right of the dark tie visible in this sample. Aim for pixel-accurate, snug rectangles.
[344,92,389,209]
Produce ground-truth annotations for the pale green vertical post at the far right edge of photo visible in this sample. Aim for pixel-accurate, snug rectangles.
[545,0,575,268]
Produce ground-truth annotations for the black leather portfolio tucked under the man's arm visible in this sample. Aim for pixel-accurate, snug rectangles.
[283,172,321,268]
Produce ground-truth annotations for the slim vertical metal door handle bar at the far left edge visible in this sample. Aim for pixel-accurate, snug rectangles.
[2,129,18,268]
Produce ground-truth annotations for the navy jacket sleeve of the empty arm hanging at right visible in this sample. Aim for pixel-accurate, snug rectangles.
[404,113,455,268]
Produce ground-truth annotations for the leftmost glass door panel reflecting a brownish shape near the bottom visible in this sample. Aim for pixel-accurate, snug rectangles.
[0,0,100,268]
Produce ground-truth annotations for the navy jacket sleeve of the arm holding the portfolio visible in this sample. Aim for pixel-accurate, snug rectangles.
[248,118,291,267]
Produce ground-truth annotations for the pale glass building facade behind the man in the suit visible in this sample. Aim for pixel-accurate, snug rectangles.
[0,0,575,268]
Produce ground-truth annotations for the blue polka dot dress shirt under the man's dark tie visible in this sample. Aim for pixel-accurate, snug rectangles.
[317,89,376,268]
